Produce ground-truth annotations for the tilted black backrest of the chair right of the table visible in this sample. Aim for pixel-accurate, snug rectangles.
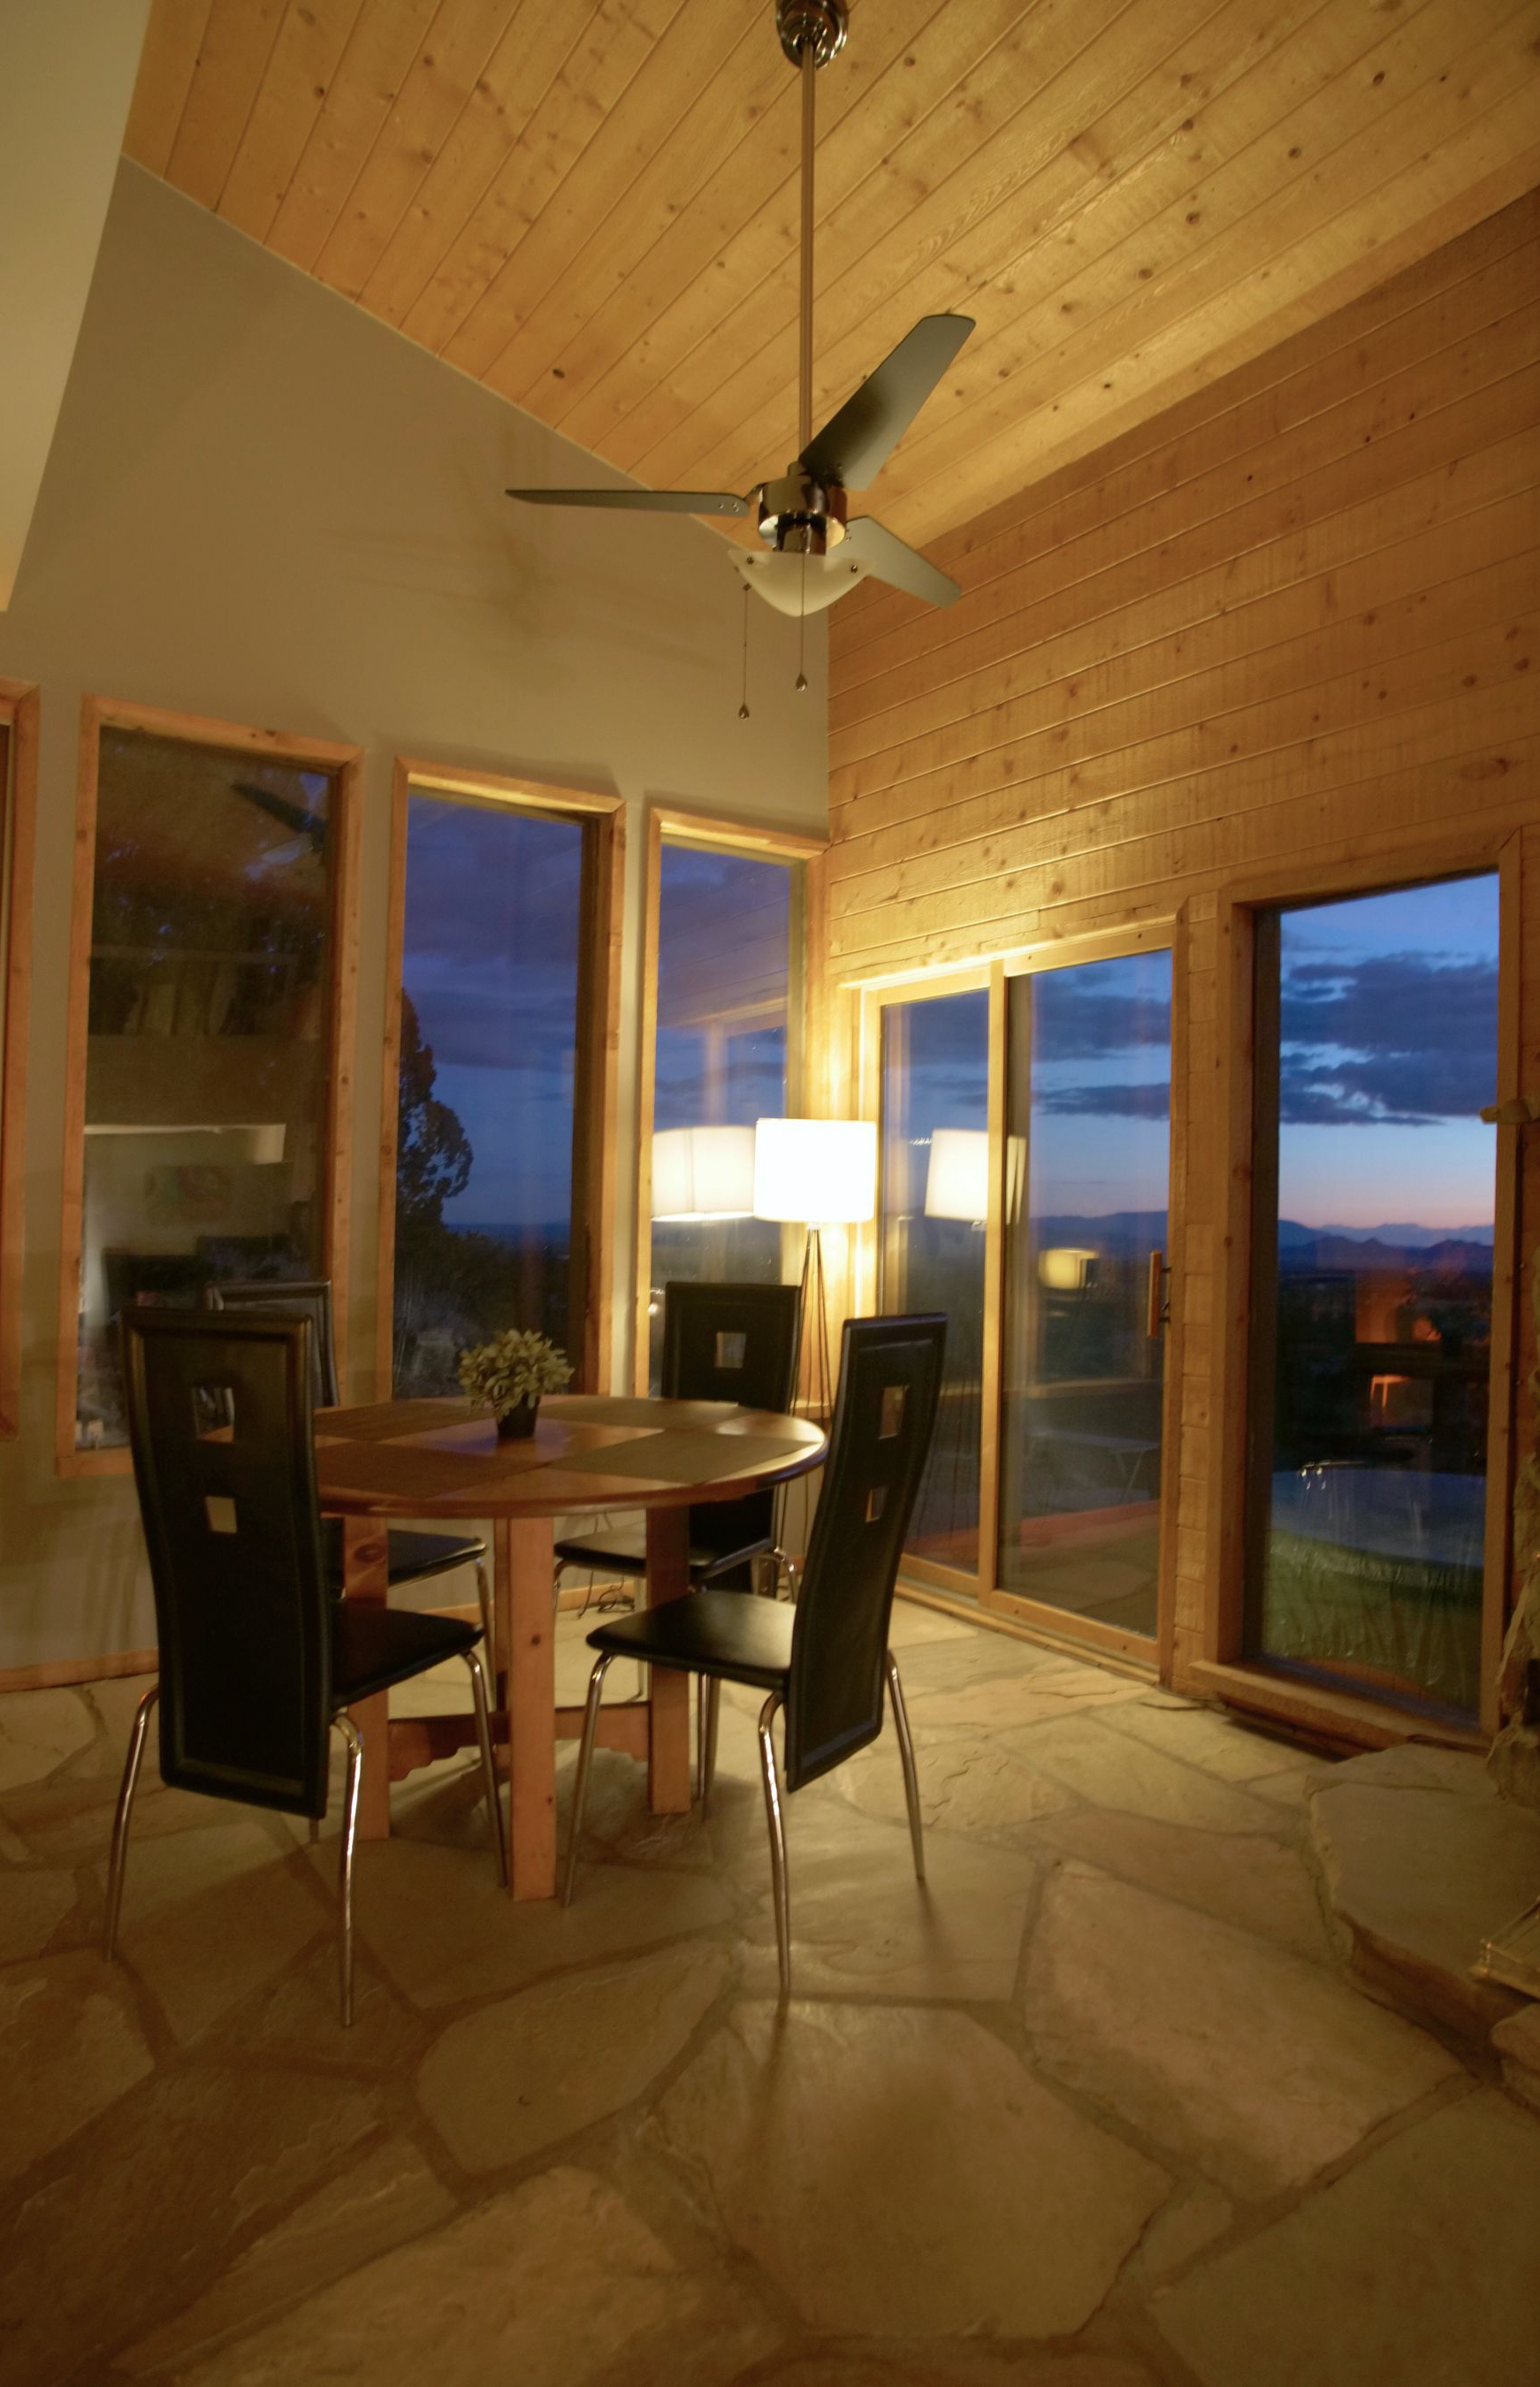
[786,1316,946,1790]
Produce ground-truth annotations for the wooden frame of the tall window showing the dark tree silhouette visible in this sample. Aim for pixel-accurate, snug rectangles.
[375,754,626,1401]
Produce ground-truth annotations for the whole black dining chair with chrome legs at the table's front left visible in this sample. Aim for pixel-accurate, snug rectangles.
[103,1306,508,2025]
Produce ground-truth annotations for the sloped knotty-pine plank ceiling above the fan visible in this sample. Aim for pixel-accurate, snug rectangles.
[126,0,1540,545]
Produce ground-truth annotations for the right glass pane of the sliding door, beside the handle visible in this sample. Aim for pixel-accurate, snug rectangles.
[1001,952,1170,1636]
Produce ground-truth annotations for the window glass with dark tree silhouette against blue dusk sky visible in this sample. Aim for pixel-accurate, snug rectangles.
[392,788,585,1397]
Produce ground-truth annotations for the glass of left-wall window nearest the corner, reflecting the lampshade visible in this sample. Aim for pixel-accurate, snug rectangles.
[650,840,800,1389]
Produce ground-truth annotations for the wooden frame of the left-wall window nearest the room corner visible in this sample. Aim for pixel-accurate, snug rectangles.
[630,805,834,1392]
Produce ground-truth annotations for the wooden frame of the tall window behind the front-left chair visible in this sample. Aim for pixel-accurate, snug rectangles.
[55,697,363,1476]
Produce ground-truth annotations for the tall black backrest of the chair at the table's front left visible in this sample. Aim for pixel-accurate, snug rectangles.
[122,1306,332,1814]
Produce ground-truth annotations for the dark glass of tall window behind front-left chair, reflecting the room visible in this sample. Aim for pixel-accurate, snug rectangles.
[76,730,334,1449]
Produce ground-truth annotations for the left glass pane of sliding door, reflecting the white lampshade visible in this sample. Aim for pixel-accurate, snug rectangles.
[879,988,988,1575]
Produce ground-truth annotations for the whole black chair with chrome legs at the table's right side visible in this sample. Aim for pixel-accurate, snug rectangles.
[561,1316,946,1998]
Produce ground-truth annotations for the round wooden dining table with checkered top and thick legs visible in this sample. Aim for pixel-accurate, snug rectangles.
[316,1394,824,1898]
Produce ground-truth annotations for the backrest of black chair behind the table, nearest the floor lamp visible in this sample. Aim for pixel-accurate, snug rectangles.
[661,1282,802,1588]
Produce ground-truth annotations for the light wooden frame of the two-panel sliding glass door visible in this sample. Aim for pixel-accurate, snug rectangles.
[850,911,1186,1674]
